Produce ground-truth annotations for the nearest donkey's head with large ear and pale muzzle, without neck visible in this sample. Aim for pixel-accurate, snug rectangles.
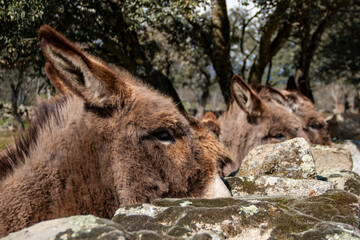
[39,26,229,204]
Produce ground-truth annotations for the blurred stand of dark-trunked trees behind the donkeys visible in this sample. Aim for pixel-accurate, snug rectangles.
[0,0,360,129]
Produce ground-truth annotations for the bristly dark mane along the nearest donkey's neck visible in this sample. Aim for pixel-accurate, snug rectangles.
[0,94,72,180]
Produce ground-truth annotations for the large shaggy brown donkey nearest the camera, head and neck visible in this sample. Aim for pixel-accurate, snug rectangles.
[0,26,230,236]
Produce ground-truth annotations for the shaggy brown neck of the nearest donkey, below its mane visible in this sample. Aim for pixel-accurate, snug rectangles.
[0,97,118,236]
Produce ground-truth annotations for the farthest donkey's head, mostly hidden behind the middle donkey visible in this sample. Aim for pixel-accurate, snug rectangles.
[252,82,331,145]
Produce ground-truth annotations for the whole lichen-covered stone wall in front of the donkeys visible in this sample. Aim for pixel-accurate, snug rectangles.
[4,138,360,240]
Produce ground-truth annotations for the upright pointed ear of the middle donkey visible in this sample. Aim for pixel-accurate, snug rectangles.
[231,74,265,117]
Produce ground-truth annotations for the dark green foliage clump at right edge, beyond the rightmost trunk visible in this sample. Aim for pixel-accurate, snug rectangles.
[314,5,360,84]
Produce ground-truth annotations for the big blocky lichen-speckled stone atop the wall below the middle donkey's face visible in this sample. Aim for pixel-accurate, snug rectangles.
[237,138,316,179]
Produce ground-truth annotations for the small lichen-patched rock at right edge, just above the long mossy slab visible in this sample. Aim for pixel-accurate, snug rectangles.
[322,170,360,197]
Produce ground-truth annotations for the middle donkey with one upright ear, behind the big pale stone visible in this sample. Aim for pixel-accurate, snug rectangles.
[219,75,308,176]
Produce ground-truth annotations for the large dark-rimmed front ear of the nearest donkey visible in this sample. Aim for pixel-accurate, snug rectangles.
[38,25,127,107]
